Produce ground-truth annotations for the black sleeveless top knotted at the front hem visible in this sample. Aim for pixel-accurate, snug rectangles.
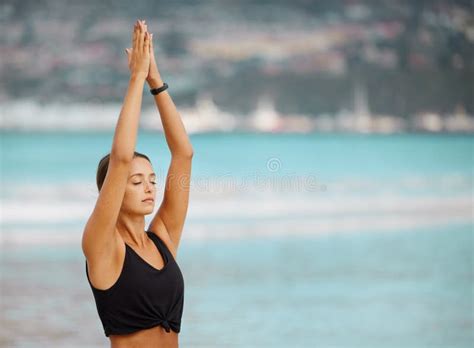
[86,231,184,337]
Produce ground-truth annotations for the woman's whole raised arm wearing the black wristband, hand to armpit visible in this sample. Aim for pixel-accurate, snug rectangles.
[134,24,194,257]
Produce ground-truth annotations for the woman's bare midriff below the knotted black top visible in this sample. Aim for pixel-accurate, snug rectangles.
[109,325,178,348]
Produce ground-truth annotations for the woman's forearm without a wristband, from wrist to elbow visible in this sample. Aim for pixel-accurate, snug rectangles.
[111,74,146,160]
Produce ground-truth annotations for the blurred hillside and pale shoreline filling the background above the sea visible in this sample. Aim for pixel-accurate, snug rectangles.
[0,0,474,133]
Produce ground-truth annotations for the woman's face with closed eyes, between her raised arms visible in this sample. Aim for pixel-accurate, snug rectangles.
[122,157,156,215]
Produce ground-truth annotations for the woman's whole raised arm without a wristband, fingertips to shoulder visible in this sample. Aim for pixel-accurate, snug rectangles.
[82,21,150,264]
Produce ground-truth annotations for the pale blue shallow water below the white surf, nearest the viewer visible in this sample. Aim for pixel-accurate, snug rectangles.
[2,225,474,347]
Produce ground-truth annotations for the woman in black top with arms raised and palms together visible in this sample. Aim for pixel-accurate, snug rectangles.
[82,21,193,348]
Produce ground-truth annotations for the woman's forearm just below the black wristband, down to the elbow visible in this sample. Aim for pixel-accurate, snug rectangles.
[148,77,193,156]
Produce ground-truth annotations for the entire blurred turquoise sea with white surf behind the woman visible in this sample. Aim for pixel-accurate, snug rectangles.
[0,131,474,347]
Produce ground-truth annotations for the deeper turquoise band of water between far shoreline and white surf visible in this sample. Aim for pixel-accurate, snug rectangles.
[1,131,474,182]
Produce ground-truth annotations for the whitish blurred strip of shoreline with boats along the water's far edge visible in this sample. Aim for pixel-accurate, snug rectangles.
[0,95,474,134]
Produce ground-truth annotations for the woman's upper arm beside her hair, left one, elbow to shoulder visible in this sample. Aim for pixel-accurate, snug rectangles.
[82,156,131,262]
